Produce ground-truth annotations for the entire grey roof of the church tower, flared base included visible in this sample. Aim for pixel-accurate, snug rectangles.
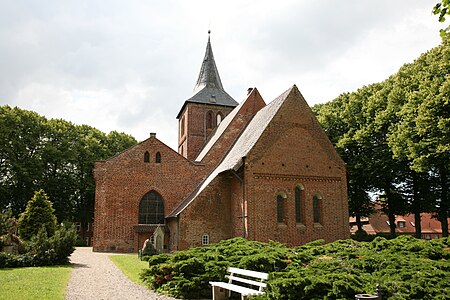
[177,31,238,119]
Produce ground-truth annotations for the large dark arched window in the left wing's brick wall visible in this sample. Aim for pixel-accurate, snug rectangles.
[139,191,164,224]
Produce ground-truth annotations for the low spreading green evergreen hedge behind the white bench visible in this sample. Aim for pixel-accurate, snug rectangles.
[141,236,450,299]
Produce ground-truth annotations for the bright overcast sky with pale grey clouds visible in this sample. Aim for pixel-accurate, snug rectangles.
[0,0,444,148]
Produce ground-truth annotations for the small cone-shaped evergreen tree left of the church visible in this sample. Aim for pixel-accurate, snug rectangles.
[19,190,57,240]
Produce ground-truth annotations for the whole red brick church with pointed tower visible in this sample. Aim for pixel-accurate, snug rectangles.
[93,33,350,252]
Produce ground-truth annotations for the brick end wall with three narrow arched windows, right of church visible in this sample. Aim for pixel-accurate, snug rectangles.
[245,86,349,245]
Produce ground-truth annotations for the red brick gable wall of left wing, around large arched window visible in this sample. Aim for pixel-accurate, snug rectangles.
[93,137,206,252]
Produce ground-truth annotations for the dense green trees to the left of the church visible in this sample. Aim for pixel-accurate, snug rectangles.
[0,106,136,233]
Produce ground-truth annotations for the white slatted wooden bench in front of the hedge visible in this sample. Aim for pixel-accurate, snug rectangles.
[209,267,269,300]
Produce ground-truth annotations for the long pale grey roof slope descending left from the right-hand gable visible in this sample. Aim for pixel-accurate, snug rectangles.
[168,85,297,217]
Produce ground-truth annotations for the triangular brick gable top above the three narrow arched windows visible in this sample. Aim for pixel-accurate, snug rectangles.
[247,86,345,175]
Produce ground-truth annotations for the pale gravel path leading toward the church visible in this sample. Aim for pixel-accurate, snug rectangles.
[66,247,176,300]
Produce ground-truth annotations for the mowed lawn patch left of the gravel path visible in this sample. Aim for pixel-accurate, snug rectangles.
[0,266,72,300]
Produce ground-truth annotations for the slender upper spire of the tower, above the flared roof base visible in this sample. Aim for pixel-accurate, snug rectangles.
[194,30,223,94]
